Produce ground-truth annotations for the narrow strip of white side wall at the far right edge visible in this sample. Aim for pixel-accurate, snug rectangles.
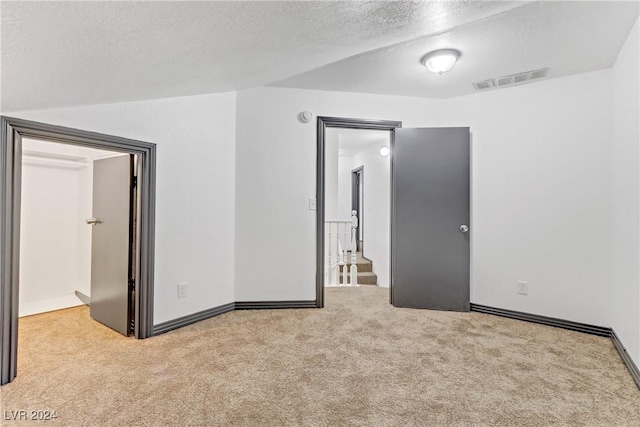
[611,21,640,366]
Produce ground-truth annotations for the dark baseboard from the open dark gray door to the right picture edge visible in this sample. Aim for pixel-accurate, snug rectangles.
[471,304,640,389]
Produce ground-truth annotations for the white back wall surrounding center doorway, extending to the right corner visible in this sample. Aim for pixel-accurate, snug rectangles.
[236,70,611,326]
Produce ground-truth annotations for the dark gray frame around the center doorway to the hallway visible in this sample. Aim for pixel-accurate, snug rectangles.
[316,116,402,308]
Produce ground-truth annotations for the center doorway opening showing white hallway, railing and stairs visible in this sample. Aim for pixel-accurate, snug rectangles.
[325,128,391,288]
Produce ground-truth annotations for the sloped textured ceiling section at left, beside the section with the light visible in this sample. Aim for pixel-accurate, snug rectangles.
[0,0,521,111]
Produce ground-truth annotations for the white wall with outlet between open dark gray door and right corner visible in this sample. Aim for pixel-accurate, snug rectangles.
[440,69,611,326]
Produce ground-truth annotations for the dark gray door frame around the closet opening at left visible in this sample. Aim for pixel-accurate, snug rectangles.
[0,116,156,385]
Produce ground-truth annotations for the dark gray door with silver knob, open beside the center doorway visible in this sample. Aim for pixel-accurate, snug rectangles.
[391,128,469,311]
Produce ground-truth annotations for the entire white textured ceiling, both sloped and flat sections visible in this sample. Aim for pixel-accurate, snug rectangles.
[0,0,638,111]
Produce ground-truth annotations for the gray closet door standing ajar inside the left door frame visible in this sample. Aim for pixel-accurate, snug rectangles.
[87,154,134,335]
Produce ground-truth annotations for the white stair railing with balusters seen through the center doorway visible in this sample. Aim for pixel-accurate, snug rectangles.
[324,211,358,287]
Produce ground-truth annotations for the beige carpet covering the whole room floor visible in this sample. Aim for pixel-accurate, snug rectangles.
[0,287,640,426]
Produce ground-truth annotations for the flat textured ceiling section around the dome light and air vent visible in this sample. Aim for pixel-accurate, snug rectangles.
[275,1,639,98]
